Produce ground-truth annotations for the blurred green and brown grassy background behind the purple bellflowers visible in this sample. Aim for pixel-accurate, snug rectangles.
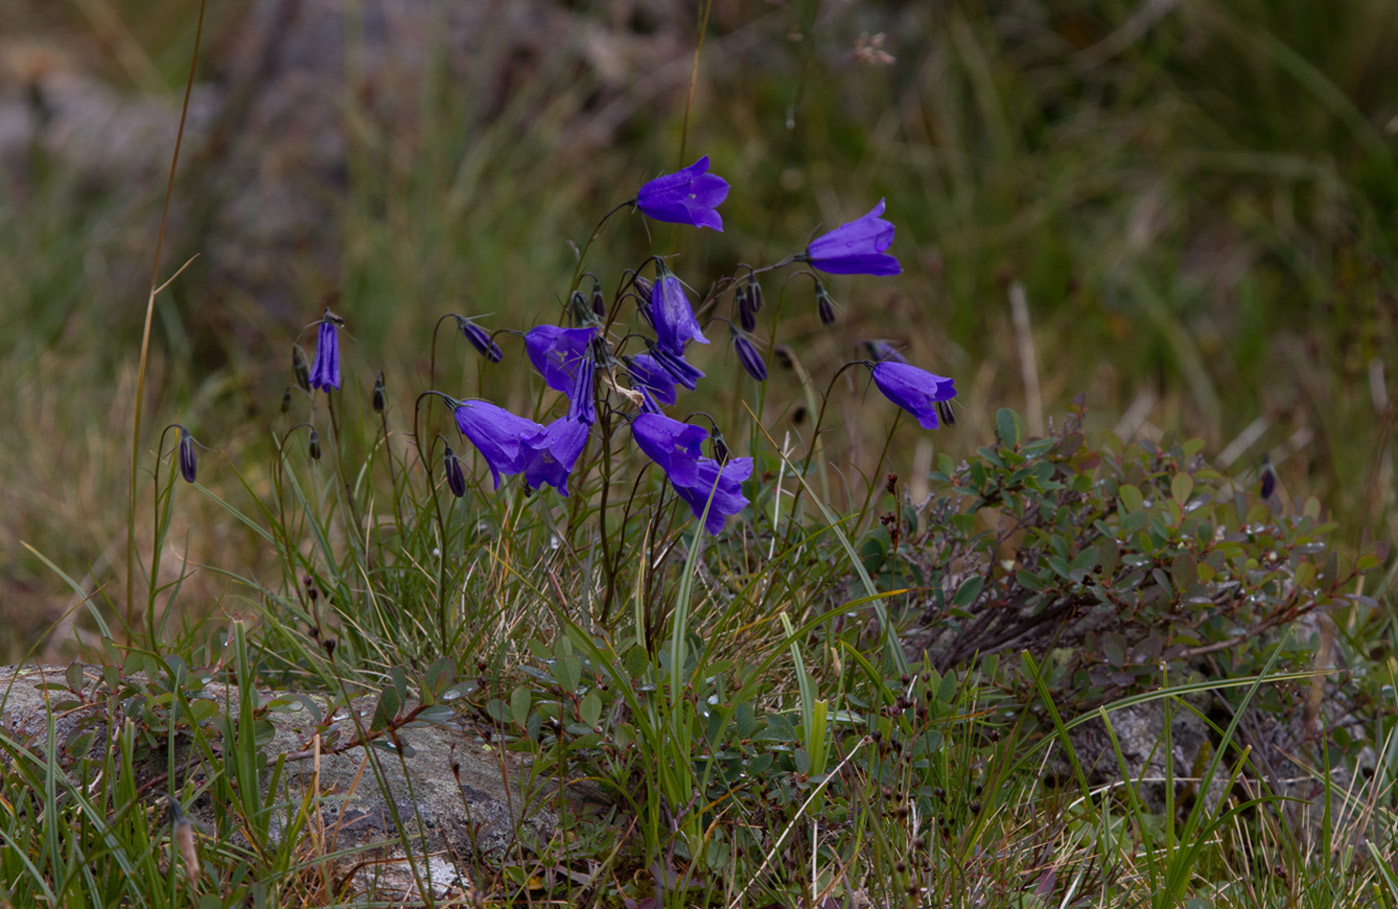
[0,0,1398,661]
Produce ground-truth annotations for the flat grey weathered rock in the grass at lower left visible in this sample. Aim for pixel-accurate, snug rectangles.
[0,666,558,899]
